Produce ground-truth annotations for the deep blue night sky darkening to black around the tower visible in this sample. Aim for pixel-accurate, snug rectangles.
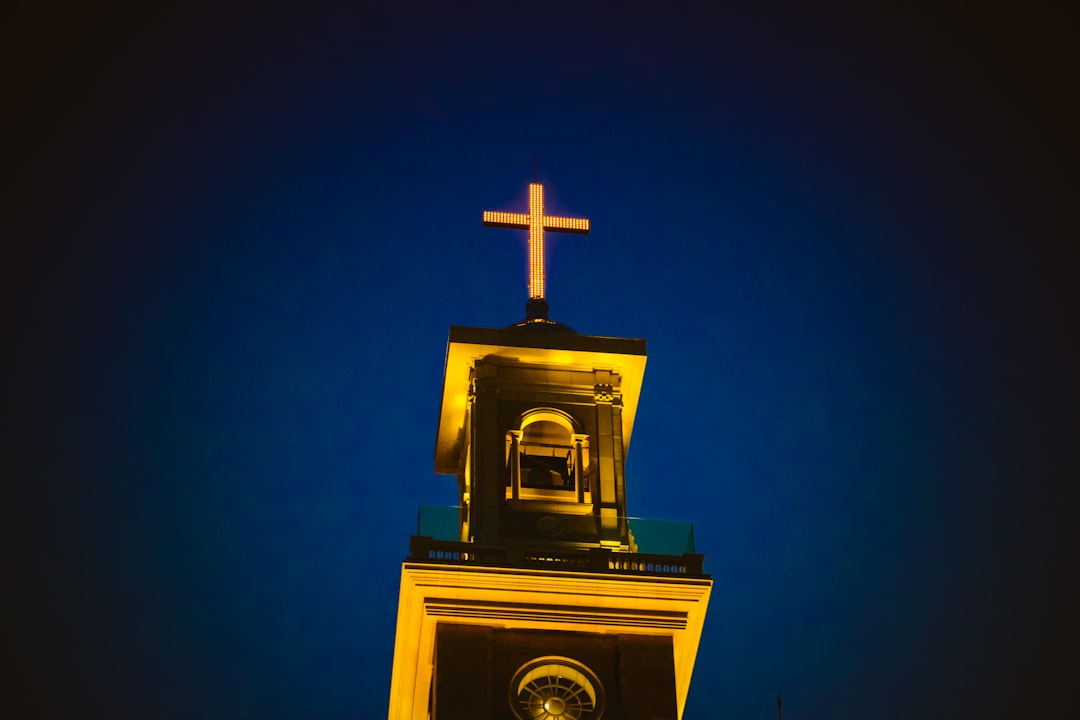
[6,3,1080,720]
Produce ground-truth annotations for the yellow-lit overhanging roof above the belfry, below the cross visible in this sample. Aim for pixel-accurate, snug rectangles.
[435,327,646,475]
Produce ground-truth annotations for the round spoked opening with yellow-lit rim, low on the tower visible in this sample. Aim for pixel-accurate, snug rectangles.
[510,655,604,720]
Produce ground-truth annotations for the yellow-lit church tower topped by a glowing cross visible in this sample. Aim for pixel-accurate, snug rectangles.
[390,184,712,720]
